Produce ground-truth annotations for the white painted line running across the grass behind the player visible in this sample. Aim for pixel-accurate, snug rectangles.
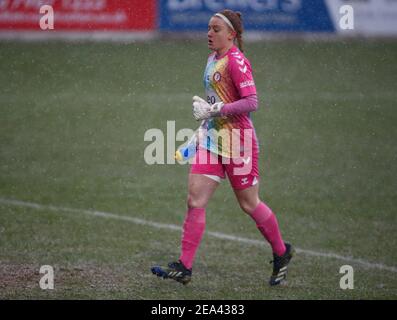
[0,198,397,272]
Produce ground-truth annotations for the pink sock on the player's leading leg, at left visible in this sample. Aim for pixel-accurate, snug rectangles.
[179,208,205,269]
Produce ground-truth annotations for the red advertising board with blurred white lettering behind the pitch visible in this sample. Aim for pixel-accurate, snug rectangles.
[0,0,157,32]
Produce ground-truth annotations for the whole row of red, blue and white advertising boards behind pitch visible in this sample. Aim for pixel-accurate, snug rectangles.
[0,0,397,38]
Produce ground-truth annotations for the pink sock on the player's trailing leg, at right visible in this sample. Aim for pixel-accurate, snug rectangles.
[251,202,286,256]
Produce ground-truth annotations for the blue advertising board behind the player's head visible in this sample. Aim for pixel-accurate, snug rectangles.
[158,0,335,32]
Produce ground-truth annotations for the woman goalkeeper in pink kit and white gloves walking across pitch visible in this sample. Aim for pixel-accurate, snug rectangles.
[152,10,293,285]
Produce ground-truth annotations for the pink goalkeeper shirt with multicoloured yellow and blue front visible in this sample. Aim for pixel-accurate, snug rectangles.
[200,46,258,158]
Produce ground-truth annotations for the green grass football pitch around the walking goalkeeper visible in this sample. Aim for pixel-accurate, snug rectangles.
[0,40,397,299]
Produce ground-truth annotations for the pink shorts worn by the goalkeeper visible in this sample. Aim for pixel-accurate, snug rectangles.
[190,147,259,190]
